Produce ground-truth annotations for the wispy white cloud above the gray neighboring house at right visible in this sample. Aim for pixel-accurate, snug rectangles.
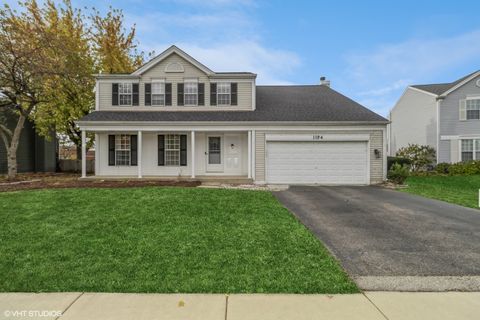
[343,30,480,115]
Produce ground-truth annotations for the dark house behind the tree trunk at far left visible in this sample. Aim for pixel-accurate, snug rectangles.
[0,112,57,174]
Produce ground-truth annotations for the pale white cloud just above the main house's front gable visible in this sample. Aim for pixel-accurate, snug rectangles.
[146,40,301,84]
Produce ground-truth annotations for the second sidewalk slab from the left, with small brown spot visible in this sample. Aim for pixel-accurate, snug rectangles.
[61,293,226,320]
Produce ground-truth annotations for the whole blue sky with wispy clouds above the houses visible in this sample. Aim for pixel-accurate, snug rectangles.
[7,0,480,116]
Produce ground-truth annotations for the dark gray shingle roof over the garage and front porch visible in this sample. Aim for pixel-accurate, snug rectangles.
[80,85,388,123]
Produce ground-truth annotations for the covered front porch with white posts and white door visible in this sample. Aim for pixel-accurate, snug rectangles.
[82,129,255,183]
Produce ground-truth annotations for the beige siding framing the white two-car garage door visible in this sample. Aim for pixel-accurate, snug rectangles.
[255,130,386,184]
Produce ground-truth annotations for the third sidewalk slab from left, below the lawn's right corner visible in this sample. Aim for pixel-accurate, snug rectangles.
[227,294,385,320]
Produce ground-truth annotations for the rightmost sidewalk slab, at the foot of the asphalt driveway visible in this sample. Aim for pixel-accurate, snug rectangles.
[365,292,480,320]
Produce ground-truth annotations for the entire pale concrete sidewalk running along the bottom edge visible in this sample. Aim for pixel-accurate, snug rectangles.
[0,292,480,320]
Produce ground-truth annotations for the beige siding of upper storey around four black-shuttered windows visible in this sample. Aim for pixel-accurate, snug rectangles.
[98,53,252,111]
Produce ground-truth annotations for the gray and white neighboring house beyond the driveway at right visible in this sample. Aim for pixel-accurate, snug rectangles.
[389,71,480,163]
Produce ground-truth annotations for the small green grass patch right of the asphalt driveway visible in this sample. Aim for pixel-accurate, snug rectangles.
[401,175,480,209]
